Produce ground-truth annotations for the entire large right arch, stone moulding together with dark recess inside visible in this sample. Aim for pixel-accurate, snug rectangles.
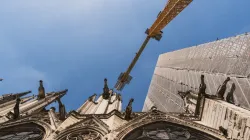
[115,110,225,140]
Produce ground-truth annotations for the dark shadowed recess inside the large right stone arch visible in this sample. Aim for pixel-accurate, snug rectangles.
[122,121,219,140]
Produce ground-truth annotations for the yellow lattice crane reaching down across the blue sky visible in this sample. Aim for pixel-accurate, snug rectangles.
[115,0,193,90]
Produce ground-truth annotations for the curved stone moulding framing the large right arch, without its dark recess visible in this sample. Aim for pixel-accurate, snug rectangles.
[116,114,225,140]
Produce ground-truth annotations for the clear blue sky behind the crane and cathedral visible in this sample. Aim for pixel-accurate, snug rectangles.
[0,0,250,111]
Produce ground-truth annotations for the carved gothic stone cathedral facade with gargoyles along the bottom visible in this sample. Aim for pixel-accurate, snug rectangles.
[0,76,250,140]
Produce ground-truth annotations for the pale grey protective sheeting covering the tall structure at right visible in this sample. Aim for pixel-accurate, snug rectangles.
[143,34,250,112]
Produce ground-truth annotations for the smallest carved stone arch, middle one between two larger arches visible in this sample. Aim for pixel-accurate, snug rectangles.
[56,126,107,140]
